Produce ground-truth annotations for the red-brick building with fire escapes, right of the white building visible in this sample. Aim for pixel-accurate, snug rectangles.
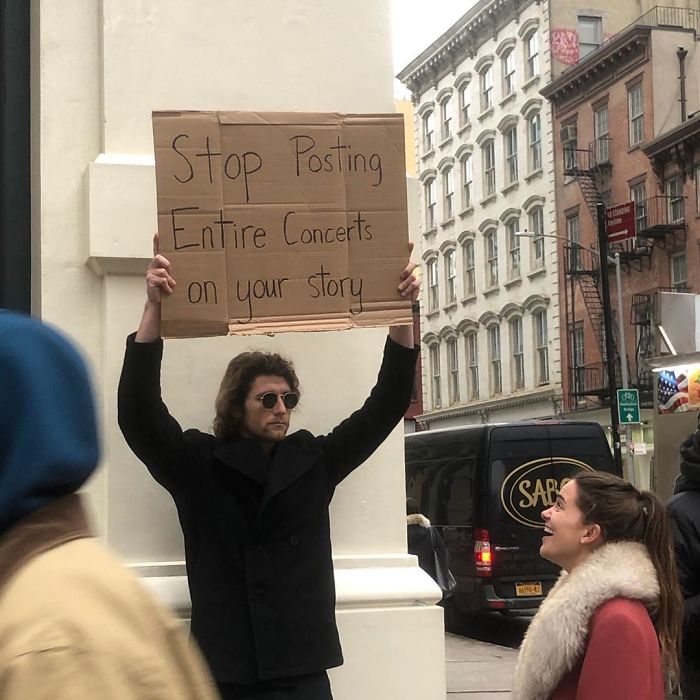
[542,7,700,484]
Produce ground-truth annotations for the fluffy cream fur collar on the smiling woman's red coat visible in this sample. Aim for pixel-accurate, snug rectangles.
[513,542,659,700]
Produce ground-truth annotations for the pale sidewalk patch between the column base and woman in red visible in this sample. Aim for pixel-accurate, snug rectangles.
[445,633,518,700]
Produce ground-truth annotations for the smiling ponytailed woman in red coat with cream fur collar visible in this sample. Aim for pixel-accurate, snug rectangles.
[513,472,683,700]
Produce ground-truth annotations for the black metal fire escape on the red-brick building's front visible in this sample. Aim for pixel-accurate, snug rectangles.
[562,139,686,407]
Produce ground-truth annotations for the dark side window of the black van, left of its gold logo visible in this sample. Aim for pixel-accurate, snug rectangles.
[406,432,478,526]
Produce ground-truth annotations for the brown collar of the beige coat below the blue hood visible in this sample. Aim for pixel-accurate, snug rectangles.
[0,493,92,594]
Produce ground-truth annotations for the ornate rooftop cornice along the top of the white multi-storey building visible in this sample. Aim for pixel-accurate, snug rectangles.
[396,0,540,95]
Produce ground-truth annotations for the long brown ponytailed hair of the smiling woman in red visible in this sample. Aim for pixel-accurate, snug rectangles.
[574,472,683,679]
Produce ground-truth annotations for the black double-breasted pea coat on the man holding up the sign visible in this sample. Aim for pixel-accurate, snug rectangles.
[119,335,418,684]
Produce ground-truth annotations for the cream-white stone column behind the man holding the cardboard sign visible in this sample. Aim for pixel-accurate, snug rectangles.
[32,0,445,700]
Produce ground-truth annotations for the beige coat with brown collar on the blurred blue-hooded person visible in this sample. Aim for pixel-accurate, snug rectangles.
[0,495,218,700]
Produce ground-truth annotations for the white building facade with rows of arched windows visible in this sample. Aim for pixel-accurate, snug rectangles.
[398,0,561,428]
